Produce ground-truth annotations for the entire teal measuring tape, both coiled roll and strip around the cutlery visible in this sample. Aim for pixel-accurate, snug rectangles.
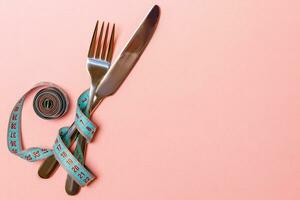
[7,82,96,187]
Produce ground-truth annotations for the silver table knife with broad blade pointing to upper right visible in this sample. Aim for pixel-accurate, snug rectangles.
[41,5,160,194]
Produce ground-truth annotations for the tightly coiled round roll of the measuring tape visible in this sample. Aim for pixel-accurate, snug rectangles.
[33,87,69,119]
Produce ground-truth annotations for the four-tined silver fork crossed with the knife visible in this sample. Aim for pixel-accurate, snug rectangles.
[65,21,115,195]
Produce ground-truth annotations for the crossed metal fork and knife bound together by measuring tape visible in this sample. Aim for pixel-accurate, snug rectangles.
[38,5,160,195]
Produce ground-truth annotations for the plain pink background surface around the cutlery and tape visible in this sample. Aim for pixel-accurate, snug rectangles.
[0,0,300,200]
